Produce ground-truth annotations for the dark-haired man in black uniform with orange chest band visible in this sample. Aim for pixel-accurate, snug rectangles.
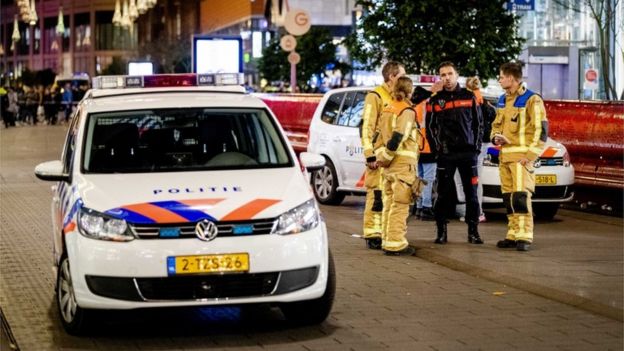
[427,61,483,244]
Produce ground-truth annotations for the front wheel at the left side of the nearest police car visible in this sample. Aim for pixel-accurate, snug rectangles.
[56,255,92,335]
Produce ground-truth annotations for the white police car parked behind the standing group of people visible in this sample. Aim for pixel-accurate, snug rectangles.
[307,82,574,218]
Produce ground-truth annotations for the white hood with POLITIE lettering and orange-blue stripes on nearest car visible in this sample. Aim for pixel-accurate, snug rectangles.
[76,167,313,224]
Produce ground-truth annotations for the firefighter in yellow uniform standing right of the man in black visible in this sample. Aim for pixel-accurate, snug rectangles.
[490,62,548,251]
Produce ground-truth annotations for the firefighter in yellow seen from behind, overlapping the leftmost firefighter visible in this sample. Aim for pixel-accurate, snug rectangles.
[376,77,419,256]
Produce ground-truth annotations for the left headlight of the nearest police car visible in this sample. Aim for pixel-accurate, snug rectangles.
[78,207,134,241]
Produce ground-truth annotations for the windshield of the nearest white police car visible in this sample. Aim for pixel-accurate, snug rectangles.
[82,108,293,173]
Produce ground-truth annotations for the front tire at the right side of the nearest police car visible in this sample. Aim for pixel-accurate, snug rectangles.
[280,251,336,325]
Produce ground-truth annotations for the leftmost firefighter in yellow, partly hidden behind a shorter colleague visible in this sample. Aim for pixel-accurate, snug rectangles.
[362,61,405,250]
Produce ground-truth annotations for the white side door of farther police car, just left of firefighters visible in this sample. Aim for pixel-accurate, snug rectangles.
[335,90,367,188]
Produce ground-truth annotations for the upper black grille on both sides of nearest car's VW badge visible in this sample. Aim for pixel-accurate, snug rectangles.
[130,218,276,239]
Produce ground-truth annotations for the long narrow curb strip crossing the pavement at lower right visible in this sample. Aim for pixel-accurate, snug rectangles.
[415,246,624,322]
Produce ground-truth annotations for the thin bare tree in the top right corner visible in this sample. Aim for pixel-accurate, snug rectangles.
[553,0,624,100]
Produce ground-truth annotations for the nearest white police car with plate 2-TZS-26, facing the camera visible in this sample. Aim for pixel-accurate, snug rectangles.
[35,74,335,334]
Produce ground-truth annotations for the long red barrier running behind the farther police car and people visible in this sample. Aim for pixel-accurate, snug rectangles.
[256,94,624,189]
